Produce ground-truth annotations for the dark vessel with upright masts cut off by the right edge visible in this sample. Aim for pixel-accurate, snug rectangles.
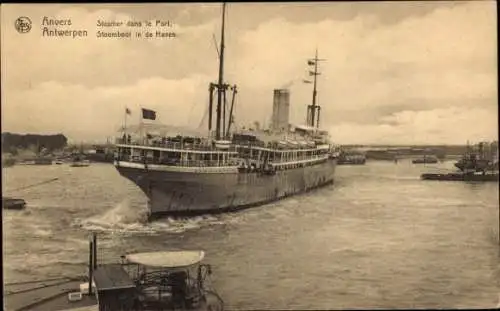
[421,143,499,182]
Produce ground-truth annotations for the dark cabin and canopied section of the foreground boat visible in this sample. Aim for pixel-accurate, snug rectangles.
[94,251,221,311]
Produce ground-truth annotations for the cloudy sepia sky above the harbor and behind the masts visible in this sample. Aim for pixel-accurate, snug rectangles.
[1,1,498,144]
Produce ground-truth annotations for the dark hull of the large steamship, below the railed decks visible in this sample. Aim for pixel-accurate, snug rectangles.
[115,159,336,218]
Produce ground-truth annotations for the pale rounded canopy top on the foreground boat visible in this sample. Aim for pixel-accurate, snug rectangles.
[125,251,205,268]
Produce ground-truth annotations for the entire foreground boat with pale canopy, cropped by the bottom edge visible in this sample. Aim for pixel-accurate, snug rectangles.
[4,235,224,311]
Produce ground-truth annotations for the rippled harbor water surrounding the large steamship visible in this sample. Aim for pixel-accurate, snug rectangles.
[2,161,500,310]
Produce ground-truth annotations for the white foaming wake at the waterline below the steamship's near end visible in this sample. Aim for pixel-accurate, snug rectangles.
[73,200,238,235]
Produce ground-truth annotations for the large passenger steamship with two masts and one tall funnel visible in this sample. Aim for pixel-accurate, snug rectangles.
[114,4,338,219]
